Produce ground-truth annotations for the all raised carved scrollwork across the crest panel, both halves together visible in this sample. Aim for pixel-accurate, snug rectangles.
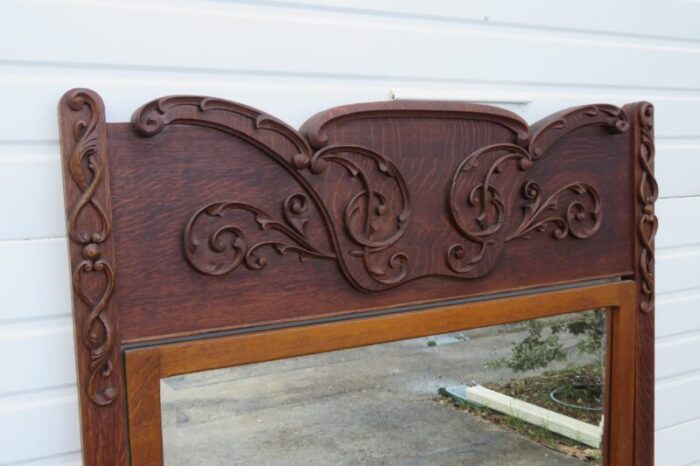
[132,97,629,292]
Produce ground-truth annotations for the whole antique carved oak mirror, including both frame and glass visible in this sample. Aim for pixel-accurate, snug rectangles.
[59,89,658,466]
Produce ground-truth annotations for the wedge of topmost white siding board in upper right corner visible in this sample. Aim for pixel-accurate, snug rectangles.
[264,0,700,40]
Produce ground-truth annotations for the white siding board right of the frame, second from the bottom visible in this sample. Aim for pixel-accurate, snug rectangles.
[655,375,700,430]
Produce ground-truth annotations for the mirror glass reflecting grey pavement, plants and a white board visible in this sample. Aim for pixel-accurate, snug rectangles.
[161,309,608,466]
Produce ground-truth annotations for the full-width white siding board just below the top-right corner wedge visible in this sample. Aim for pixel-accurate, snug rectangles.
[0,1,700,89]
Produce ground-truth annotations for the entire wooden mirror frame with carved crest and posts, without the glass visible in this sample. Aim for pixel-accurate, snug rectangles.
[59,89,658,466]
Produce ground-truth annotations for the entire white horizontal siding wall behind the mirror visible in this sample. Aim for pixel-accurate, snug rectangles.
[0,0,700,466]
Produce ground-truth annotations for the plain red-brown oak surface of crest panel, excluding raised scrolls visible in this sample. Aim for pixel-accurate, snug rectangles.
[108,102,634,341]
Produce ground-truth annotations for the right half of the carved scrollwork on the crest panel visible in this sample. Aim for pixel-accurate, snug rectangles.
[446,104,629,276]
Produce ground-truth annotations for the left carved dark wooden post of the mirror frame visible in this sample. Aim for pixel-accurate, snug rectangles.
[59,89,126,465]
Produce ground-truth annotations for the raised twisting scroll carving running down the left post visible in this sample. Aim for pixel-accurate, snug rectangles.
[66,90,117,406]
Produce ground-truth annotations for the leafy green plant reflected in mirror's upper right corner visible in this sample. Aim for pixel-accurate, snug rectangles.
[487,311,605,372]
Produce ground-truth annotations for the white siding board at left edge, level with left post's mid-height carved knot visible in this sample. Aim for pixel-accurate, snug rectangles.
[0,239,71,324]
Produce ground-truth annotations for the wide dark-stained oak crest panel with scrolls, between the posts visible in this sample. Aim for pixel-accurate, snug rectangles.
[109,100,634,342]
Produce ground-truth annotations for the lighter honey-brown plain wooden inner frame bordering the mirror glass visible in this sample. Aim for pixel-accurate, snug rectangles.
[125,281,637,466]
